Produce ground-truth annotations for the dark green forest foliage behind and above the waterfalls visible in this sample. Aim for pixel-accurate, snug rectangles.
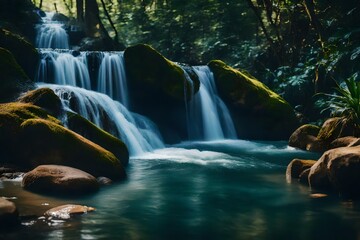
[3,0,360,122]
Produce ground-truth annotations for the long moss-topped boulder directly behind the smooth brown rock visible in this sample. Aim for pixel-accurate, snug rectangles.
[19,119,125,179]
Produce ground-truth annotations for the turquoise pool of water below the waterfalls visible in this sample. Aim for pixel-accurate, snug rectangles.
[0,140,360,239]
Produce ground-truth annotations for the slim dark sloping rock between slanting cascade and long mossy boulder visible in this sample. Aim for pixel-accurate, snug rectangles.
[67,112,129,166]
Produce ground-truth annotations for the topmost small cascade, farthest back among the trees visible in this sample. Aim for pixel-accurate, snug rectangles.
[36,12,69,49]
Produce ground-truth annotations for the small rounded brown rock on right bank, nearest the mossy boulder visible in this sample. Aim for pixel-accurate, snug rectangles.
[289,124,320,150]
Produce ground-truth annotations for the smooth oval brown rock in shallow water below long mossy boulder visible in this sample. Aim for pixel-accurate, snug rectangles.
[22,165,99,195]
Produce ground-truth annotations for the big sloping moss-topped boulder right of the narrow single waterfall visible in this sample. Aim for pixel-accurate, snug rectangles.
[208,60,299,140]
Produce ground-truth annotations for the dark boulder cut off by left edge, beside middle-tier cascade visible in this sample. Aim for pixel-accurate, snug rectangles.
[0,47,33,103]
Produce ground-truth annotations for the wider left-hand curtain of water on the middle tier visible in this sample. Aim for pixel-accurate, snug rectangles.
[36,50,91,89]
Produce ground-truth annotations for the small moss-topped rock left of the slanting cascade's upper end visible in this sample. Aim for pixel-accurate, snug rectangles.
[18,88,62,117]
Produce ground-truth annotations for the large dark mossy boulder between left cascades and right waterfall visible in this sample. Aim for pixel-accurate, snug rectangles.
[124,44,200,142]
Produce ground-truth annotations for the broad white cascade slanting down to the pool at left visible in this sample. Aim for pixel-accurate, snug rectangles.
[39,84,164,156]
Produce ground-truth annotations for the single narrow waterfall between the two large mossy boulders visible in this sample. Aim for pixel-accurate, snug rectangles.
[187,66,237,141]
